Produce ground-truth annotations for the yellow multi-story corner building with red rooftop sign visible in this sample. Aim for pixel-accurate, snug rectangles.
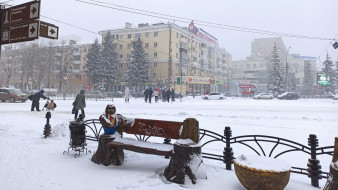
[100,22,231,94]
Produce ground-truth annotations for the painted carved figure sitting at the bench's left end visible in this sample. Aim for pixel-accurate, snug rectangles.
[99,105,118,135]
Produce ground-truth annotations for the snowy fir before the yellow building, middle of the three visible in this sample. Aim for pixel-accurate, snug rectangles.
[101,32,119,90]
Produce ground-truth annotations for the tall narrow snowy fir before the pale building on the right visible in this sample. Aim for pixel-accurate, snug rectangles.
[268,44,285,95]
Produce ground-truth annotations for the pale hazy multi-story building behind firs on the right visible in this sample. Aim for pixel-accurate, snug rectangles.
[230,38,316,93]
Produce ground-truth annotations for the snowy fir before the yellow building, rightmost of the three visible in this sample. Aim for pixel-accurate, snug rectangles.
[126,38,148,86]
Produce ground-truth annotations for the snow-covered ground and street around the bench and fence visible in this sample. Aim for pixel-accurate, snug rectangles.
[0,97,338,190]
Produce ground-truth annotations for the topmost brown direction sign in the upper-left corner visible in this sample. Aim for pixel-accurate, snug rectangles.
[2,1,40,26]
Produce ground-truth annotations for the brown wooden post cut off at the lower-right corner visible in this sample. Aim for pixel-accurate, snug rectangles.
[323,137,338,190]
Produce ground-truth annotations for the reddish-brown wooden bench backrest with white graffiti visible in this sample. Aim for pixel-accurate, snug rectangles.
[119,118,199,143]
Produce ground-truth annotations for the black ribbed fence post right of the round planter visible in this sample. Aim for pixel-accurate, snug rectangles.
[307,134,322,187]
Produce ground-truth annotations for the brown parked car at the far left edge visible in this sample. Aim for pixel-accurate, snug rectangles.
[0,88,28,102]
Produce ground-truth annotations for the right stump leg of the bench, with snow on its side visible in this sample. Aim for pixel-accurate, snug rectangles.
[164,139,207,184]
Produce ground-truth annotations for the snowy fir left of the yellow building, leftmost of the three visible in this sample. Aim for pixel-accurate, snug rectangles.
[86,39,102,89]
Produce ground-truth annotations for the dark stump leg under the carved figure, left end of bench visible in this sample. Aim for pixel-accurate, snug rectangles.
[92,135,124,166]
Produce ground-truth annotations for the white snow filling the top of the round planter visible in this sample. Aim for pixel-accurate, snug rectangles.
[235,154,291,172]
